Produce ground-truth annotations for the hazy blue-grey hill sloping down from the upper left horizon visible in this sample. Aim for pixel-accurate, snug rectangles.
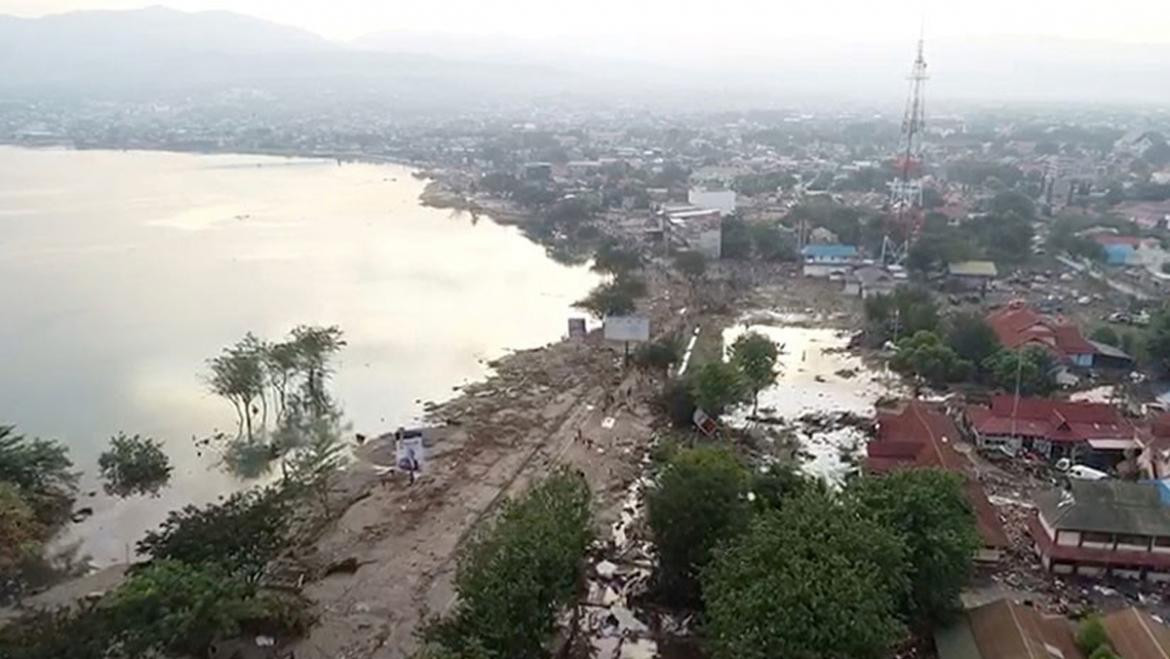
[0,7,594,109]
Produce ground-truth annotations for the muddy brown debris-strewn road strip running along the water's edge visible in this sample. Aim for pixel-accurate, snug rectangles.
[286,334,652,659]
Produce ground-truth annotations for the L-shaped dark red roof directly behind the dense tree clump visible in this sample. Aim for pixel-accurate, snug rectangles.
[865,400,1007,562]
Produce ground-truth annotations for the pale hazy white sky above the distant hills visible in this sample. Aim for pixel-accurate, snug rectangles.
[0,0,1170,44]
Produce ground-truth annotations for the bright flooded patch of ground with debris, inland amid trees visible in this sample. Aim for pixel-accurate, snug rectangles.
[723,313,899,483]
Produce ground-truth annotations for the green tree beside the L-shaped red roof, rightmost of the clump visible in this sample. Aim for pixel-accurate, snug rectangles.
[847,468,979,629]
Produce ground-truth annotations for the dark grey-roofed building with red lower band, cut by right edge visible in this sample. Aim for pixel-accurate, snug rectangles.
[1028,479,1170,582]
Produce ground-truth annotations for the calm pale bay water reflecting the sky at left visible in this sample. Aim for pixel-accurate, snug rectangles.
[0,146,596,564]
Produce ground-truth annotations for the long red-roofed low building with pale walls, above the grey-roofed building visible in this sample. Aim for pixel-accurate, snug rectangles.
[964,396,1138,468]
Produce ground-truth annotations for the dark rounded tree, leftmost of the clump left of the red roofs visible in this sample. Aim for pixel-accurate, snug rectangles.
[647,447,750,606]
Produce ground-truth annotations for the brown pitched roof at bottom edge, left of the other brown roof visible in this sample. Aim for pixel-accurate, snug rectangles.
[935,599,1085,659]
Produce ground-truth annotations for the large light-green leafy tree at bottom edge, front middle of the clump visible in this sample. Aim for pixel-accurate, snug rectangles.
[702,493,906,659]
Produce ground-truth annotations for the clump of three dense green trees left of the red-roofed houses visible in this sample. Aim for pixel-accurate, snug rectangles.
[647,447,978,659]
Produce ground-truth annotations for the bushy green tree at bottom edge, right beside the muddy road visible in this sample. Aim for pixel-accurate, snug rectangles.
[422,471,592,659]
